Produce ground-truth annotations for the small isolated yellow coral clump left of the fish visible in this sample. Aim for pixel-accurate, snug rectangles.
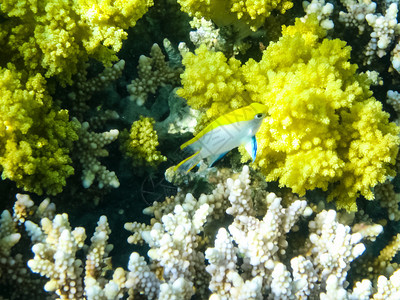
[121,116,167,167]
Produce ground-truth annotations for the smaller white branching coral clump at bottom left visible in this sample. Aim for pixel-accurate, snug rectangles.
[25,214,119,299]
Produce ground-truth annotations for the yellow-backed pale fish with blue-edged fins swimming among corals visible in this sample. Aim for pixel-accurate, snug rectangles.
[174,103,267,172]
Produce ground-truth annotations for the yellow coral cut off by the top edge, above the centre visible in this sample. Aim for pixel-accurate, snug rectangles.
[178,0,293,31]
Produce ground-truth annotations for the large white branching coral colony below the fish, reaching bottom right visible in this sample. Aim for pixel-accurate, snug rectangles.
[126,166,399,299]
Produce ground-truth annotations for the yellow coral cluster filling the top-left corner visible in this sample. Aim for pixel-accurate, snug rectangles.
[0,0,153,83]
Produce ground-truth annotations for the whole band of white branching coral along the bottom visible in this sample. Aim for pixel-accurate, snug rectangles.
[0,166,400,299]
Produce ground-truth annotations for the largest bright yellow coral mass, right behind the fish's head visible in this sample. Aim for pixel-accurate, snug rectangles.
[178,15,399,211]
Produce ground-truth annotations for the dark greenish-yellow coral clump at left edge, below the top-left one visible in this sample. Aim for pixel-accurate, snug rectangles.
[0,64,78,194]
